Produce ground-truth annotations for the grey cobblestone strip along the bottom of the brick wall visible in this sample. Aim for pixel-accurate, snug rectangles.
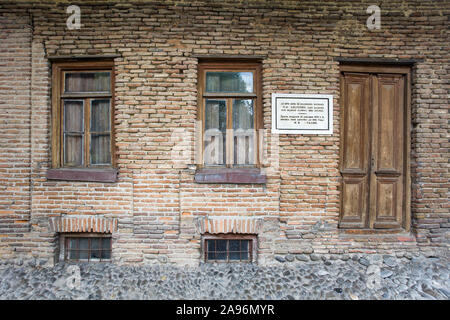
[0,254,450,300]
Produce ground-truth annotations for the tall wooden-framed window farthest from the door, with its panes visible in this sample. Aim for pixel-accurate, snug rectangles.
[49,60,115,180]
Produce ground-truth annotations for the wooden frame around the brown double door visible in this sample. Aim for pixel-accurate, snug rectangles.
[339,62,412,234]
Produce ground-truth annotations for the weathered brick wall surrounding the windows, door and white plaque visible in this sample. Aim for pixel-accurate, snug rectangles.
[0,1,450,264]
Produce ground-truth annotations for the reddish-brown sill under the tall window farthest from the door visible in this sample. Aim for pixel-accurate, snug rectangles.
[46,168,117,182]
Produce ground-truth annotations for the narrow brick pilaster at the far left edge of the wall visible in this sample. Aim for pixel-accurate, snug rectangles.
[0,5,32,257]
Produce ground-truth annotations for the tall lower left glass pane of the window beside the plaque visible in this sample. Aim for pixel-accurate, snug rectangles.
[204,99,227,165]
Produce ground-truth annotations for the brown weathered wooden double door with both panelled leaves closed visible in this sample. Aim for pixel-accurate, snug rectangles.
[339,72,409,229]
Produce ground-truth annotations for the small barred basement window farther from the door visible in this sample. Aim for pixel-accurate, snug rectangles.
[64,236,111,262]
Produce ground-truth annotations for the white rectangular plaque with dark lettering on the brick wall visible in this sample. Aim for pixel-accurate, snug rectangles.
[272,93,333,134]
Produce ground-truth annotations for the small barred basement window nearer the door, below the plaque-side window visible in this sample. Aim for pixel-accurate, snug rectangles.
[204,236,255,262]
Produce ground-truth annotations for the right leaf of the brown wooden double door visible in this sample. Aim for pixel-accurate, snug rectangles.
[369,74,405,228]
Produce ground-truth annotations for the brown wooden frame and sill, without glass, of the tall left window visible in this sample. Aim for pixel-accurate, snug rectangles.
[47,59,117,182]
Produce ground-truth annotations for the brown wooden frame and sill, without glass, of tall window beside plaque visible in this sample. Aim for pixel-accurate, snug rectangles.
[195,59,266,183]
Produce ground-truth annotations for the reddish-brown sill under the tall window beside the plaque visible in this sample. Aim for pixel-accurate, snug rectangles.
[194,168,266,184]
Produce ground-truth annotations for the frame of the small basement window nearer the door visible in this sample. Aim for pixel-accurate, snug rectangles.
[202,233,257,263]
